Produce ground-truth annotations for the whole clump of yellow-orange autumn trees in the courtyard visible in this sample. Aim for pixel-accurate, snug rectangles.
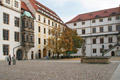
[47,27,83,57]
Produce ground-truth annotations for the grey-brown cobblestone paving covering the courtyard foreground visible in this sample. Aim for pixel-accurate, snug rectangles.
[0,60,119,80]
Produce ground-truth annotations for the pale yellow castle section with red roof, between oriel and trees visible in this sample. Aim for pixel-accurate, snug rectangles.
[22,0,64,59]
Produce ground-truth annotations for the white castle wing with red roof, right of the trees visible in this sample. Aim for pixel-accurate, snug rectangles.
[66,7,120,56]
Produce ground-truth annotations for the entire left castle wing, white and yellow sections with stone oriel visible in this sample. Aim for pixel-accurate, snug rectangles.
[0,0,65,60]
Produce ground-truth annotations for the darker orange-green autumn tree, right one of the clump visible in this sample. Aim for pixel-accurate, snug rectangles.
[60,28,83,53]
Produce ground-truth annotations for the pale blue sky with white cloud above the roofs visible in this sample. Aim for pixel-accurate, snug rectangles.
[37,0,120,22]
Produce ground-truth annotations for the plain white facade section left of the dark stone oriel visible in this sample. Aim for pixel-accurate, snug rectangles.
[0,0,21,60]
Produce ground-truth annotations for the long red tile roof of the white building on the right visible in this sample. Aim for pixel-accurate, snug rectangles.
[66,7,120,24]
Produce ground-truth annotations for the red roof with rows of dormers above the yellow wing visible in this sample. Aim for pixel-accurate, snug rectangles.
[29,0,63,22]
